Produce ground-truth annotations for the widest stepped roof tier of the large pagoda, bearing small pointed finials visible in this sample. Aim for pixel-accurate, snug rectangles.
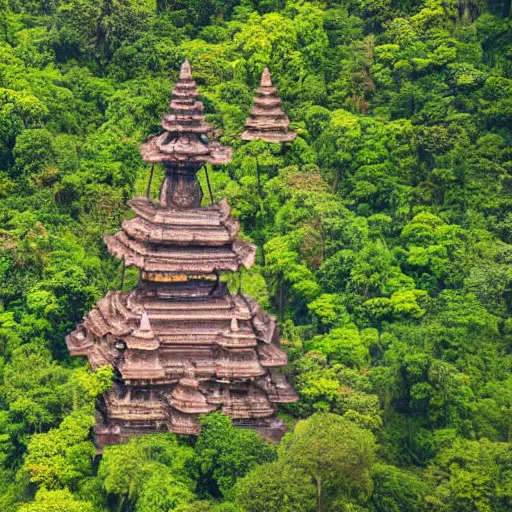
[67,280,286,384]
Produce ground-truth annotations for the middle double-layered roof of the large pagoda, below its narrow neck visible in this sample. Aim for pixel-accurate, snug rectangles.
[105,197,256,275]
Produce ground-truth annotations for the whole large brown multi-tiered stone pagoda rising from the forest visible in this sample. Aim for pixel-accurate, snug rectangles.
[66,61,297,450]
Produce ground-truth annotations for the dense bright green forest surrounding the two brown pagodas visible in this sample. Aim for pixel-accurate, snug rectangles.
[0,0,512,512]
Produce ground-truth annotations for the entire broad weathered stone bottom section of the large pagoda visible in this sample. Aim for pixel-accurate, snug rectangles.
[66,282,297,444]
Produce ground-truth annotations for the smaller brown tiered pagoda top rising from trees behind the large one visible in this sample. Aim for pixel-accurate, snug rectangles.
[242,68,297,143]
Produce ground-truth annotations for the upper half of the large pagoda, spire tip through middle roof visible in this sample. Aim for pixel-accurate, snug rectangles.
[105,60,256,281]
